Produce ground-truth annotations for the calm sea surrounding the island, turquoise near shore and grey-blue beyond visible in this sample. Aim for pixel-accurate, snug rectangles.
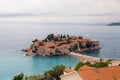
[0,23,120,80]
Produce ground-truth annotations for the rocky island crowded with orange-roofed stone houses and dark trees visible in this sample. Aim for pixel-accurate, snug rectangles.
[23,34,100,56]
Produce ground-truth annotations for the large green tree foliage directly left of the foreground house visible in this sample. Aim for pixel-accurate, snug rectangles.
[26,65,65,80]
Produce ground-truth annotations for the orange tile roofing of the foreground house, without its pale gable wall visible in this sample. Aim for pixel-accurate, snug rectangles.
[65,65,120,80]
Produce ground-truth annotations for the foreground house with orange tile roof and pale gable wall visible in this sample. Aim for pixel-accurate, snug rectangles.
[60,65,120,80]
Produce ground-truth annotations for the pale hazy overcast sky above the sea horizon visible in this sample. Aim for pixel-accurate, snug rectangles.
[0,0,120,23]
